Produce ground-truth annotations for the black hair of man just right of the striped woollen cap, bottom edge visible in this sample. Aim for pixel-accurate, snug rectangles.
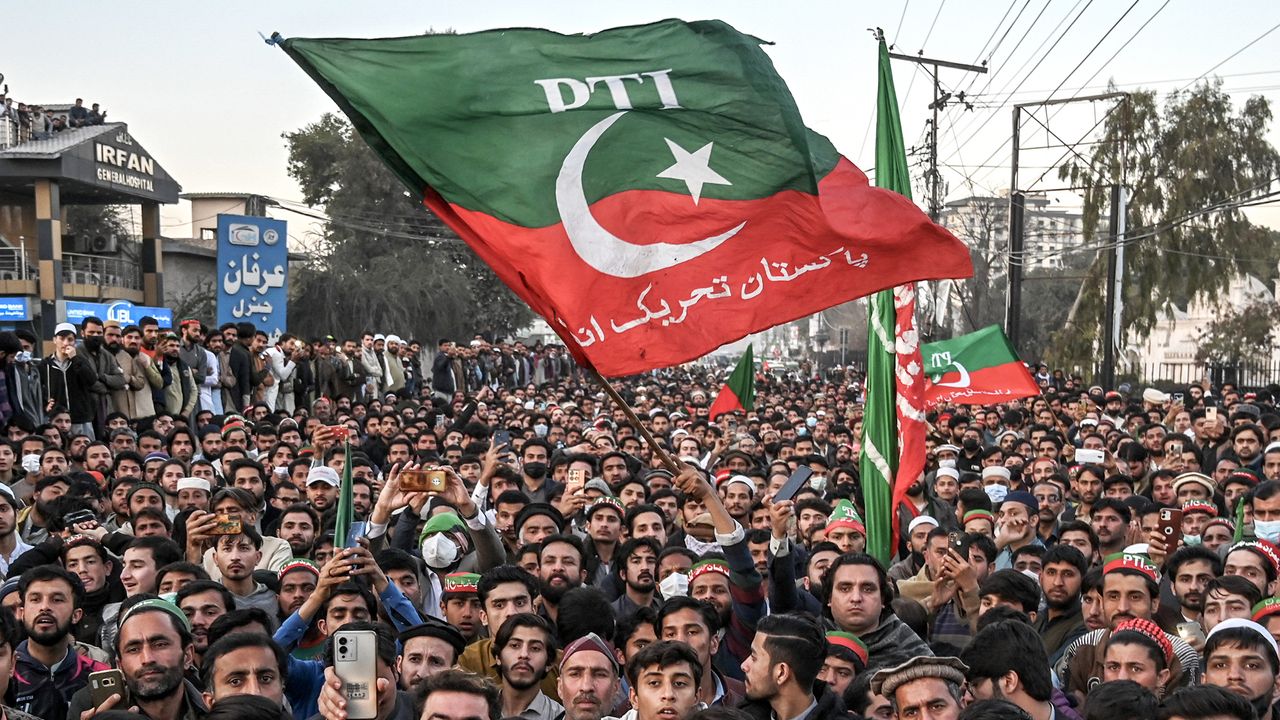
[960,620,1053,702]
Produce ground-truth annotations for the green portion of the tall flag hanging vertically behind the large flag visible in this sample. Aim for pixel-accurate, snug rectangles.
[859,38,911,564]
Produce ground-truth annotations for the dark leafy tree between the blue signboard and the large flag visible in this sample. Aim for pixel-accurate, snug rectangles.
[284,113,532,342]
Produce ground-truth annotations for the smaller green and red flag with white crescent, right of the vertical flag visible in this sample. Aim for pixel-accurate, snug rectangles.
[924,325,1039,405]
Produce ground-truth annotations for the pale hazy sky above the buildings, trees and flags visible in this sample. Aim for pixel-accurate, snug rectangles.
[0,0,1280,237]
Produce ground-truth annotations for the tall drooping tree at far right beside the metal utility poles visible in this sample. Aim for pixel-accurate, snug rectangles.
[1048,81,1280,369]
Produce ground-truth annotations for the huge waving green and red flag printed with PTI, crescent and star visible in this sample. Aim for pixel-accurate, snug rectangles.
[274,20,973,377]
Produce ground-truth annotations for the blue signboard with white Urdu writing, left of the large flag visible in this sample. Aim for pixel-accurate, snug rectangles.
[214,215,289,337]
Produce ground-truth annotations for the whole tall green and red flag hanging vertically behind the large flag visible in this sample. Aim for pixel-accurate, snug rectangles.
[859,38,925,564]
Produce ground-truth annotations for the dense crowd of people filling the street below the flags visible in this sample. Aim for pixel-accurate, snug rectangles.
[0,318,1280,720]
